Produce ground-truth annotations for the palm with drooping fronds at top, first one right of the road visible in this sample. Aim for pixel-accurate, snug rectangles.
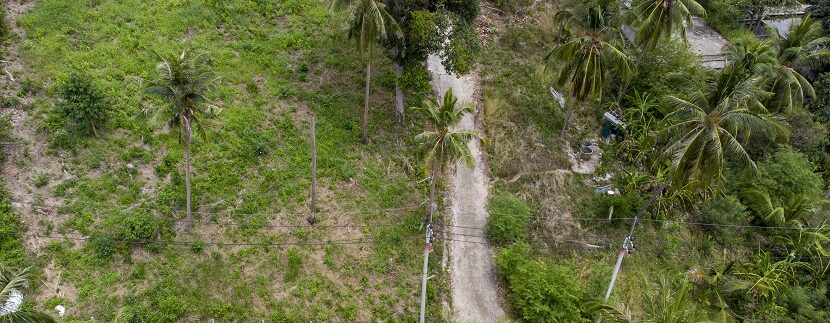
[545,0,632,138]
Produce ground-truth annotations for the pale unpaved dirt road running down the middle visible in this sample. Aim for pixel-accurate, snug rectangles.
[427,55,504,323]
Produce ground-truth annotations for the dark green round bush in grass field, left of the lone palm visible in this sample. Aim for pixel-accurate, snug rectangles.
[57,73,110,136]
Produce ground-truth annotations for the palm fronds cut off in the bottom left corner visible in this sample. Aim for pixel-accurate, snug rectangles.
[0,265,55,323]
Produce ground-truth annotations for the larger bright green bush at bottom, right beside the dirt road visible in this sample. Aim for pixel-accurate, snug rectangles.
[496,243,581,322]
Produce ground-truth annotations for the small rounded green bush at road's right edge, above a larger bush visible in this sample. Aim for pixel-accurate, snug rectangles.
[485,193,531,246]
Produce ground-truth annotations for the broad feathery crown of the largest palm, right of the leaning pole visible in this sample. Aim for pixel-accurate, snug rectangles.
[663,51,784,190]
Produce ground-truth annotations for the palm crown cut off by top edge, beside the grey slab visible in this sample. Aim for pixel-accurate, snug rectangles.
[634,0,706,49]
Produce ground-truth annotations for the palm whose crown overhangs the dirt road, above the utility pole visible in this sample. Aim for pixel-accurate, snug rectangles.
[410,89,478,223]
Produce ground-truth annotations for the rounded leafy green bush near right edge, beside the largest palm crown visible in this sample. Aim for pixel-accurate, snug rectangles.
[754,149,824,205]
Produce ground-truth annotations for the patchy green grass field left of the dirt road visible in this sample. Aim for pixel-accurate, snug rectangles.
[11,0,445,322]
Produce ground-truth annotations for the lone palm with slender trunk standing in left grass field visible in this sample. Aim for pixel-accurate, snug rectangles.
[145,51,219,231]
